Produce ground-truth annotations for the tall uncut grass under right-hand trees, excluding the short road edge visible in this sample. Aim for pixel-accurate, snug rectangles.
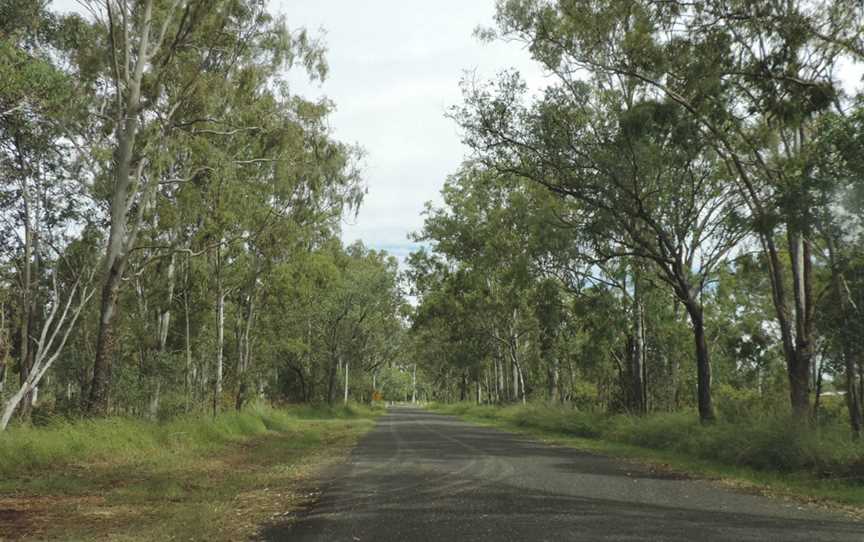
[437,403,864,481]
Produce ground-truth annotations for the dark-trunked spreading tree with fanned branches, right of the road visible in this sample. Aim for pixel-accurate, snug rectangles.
[457,74,743,421]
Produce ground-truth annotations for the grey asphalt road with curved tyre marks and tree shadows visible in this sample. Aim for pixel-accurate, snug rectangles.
[265,408,864,542]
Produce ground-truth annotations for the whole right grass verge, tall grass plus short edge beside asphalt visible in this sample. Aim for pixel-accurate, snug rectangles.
[431,403,864,514]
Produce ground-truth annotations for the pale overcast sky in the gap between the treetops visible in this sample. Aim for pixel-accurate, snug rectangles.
[271,0,542,259]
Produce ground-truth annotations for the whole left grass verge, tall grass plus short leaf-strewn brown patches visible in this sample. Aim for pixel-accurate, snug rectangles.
[0,405,379,541]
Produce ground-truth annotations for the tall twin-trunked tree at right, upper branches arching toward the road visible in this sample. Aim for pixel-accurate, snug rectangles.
[486,0,864,422]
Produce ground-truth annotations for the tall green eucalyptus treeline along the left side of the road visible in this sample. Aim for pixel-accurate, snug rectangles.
[0,0,404,434]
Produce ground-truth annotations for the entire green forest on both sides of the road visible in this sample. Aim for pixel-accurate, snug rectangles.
[0,0,864,446]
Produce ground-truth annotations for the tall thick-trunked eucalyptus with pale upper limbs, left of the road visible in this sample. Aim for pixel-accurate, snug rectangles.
[74,0,332,412]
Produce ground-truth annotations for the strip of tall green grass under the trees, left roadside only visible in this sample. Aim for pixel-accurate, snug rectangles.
[0,404,374,478]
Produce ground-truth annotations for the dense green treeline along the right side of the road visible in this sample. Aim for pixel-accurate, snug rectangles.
[410,0,864,435]
